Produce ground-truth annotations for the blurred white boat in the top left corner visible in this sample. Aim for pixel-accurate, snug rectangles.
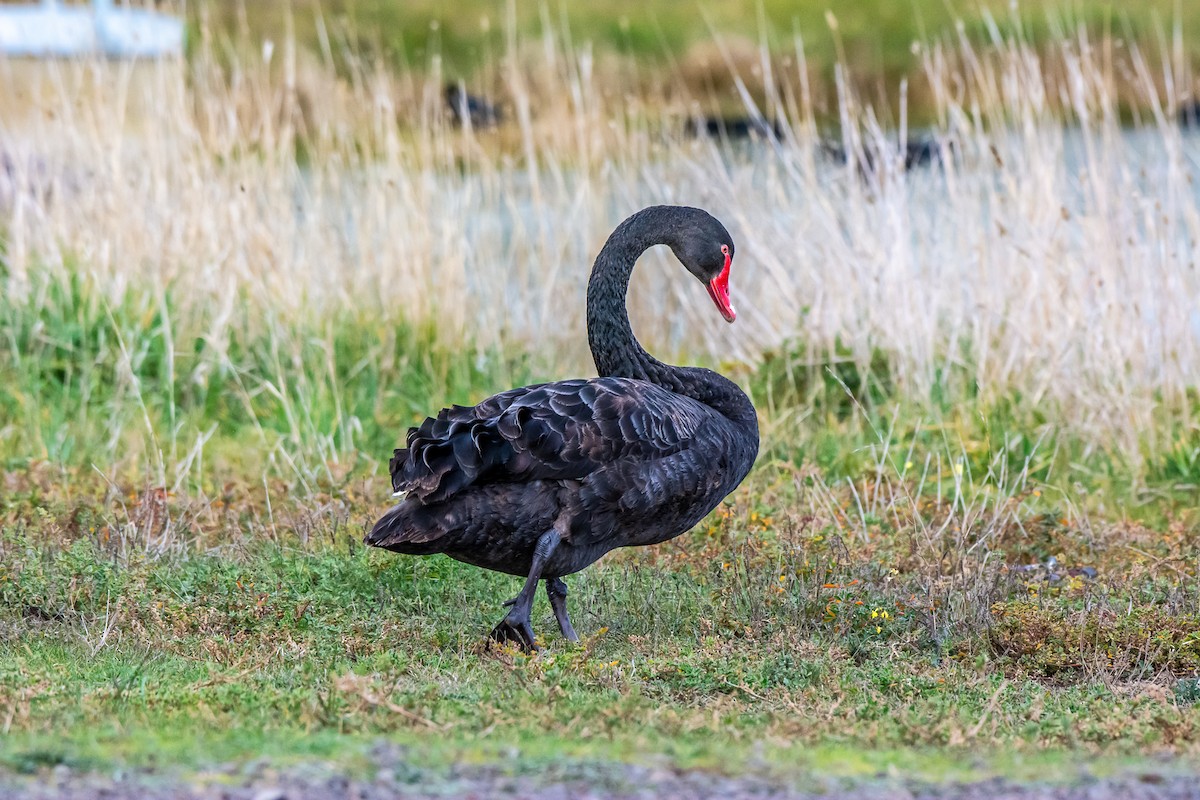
[0,0,184,59]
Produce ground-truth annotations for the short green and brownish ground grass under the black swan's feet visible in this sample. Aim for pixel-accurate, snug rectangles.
[0,487,1200,775]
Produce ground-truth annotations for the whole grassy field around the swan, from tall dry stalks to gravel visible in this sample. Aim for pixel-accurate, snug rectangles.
[0,6,1200,780]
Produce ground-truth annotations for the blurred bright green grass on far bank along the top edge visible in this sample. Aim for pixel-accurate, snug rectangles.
[210,0,1200,76]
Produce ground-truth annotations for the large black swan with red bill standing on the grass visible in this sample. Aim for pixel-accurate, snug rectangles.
[366,205,758,651]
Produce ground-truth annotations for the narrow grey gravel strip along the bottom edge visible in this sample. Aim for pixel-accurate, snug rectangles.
[0,748,1200,800]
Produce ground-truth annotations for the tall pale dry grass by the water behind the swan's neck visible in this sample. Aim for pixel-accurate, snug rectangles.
[0,14,1200,474]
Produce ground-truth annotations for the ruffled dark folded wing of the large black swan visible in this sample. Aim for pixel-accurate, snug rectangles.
[390,378,715,504]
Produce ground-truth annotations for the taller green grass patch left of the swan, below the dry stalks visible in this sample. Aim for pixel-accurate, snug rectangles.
[0,271,540,482]
